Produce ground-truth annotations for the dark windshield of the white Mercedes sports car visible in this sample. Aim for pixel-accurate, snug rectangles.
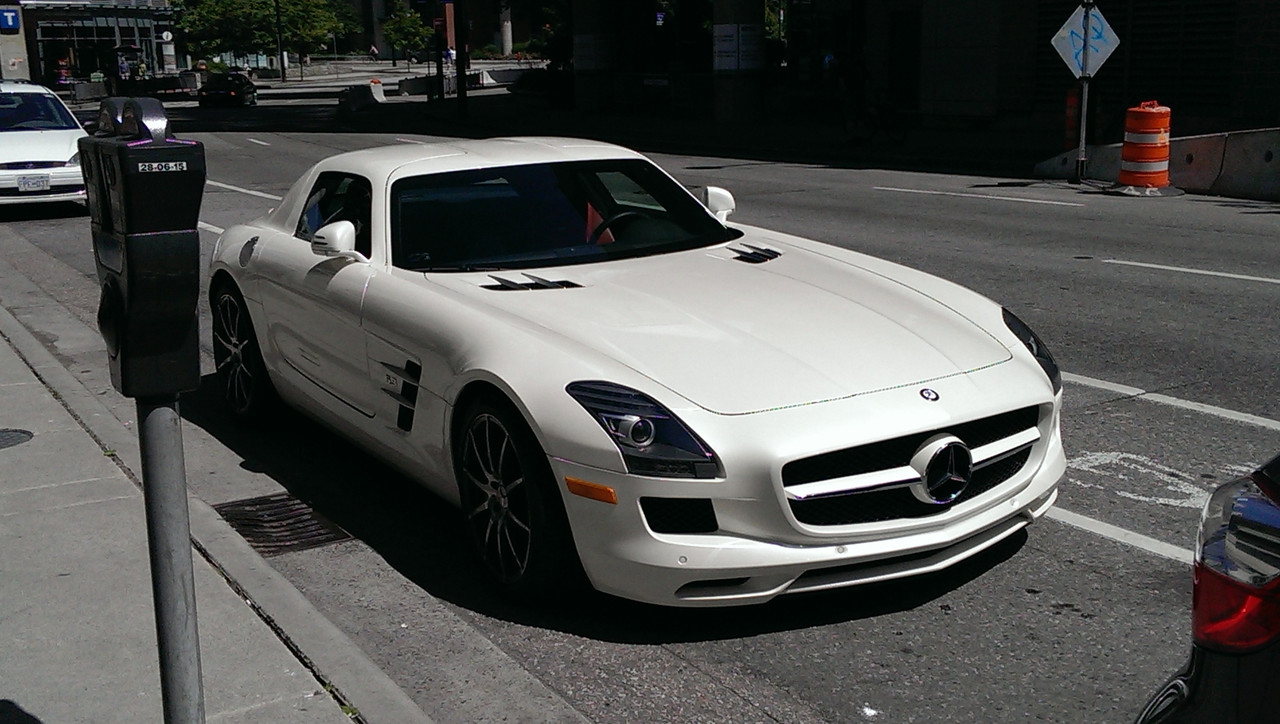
[392,159,741,271]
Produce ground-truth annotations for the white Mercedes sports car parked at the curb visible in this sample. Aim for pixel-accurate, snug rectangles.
[210,138,1065,606]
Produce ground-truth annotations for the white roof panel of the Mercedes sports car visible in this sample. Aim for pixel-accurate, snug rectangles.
[320,137,644,178]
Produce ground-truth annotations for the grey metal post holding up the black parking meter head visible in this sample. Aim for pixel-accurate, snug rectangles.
[137,395,205,724]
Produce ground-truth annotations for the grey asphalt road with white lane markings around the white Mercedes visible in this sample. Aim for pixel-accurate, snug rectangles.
[0,132,1280,723]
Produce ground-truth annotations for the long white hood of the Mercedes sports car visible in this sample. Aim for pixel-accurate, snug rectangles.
[440,238,1011,414]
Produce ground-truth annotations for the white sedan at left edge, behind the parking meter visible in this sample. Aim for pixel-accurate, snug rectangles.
[0,81,84,203]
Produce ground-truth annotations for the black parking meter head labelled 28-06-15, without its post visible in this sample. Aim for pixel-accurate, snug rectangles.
[79,97,205,398]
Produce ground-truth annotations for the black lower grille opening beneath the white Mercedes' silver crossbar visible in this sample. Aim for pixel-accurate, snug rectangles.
[791,449,1032,526]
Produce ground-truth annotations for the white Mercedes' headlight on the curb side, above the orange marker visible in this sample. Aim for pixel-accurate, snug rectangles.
[564,382,721,478]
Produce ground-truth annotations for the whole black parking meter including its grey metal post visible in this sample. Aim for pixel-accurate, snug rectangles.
[77,97,205,724]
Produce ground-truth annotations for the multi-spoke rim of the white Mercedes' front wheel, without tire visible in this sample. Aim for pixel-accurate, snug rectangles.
[462,413,532,583]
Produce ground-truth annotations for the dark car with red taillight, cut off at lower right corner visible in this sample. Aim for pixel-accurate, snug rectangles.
[1138,457,1280,724]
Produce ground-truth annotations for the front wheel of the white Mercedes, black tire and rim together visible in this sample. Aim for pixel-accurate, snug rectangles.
[453,398,584,600]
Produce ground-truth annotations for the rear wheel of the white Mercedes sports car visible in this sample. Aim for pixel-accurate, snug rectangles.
[210,283,275,421]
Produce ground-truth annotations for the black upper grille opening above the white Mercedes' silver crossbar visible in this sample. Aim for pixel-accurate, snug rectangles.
[782,407,1039,487]
